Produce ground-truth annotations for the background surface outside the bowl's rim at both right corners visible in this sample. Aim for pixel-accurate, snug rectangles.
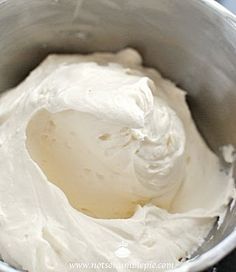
[204,0,236,272]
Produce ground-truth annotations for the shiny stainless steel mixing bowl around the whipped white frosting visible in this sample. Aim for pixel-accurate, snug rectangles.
[0,0,236,272]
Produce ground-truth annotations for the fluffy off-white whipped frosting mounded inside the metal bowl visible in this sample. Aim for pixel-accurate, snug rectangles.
[0,49,235,272]
